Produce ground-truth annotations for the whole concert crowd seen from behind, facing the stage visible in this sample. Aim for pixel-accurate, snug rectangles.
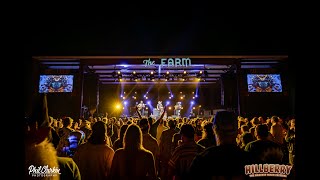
[26,95,295,180]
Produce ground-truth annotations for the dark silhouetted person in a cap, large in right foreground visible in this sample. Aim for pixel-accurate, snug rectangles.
[188,111,249,179]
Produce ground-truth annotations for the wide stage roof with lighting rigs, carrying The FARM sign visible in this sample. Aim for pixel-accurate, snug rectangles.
[33,55,288,85]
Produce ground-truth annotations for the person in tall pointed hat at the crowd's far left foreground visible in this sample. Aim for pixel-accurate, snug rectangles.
[24,94,81,180]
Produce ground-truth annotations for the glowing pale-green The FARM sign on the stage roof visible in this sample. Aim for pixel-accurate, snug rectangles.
[143,58,191,67]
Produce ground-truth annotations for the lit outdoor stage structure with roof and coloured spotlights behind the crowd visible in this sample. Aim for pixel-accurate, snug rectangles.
[33,55,290,116]
